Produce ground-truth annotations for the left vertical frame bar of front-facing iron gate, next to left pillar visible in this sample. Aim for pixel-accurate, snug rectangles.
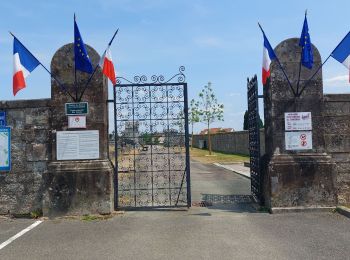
[113,86,119,209]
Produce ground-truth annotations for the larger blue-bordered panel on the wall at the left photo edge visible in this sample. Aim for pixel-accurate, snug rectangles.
[0,127,11,171]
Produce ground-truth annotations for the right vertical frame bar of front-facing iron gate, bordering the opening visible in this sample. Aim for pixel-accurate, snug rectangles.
[183,83,193,207]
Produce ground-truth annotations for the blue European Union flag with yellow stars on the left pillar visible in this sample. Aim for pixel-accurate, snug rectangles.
[74,15,93,74]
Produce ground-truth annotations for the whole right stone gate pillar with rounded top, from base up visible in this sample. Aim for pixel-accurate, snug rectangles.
[263,38,336,210]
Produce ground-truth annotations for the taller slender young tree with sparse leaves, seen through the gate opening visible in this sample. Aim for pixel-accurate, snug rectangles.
[198,82,224,155]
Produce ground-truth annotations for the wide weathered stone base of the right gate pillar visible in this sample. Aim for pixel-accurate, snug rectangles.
[268,154,337,207]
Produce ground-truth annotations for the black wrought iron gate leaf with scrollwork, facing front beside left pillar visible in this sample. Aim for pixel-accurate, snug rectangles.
[114,67,191,208]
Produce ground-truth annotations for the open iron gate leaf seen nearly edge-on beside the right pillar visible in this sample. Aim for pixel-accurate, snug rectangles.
[247,75,262,202]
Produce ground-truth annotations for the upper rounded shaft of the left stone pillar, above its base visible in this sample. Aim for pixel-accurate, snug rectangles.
[51,43,108,160]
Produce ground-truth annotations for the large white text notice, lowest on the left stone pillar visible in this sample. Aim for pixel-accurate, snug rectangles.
[56,130,100,160]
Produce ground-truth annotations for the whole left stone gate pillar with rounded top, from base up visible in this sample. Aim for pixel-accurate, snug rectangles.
[43,43,114,216]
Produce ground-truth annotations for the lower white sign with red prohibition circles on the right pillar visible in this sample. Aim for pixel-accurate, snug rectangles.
[285,131,312,150]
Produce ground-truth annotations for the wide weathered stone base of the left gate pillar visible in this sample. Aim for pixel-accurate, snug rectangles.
[44,160,114,216]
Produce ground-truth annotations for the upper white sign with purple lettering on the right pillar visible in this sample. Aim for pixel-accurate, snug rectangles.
[284,112,312,131]
